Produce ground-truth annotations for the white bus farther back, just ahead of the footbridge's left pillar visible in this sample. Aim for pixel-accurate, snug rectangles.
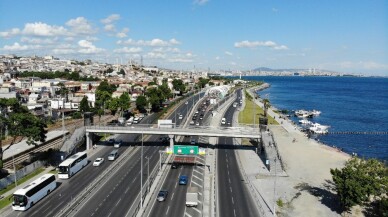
[58,152,88,179]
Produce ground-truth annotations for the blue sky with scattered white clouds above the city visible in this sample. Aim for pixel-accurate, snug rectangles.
[0,0,388,76]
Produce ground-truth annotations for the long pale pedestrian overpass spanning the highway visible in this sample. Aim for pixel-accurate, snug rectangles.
[85,124,261,149]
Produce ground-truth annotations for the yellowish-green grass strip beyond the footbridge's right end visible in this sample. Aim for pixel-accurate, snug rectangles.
[238,99,279,125]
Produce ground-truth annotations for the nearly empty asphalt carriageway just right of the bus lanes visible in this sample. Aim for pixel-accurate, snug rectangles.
[69,94,203,217]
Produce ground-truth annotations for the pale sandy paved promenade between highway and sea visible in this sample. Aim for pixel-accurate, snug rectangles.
[233,88,363,217]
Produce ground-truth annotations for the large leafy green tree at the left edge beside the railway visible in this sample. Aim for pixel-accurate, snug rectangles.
[0,98,47,168]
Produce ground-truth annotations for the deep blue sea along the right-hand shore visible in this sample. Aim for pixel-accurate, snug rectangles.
[243,76,388,162]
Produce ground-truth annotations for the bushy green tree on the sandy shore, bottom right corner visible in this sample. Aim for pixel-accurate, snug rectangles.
[330,157,388,210]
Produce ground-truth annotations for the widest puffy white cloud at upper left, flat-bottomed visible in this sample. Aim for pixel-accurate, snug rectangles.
[22,22,69,36]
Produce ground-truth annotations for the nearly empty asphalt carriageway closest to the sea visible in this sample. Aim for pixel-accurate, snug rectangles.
[217,90,259,217]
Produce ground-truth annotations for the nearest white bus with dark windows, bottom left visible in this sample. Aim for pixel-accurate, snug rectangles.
[12,174,57,211]
